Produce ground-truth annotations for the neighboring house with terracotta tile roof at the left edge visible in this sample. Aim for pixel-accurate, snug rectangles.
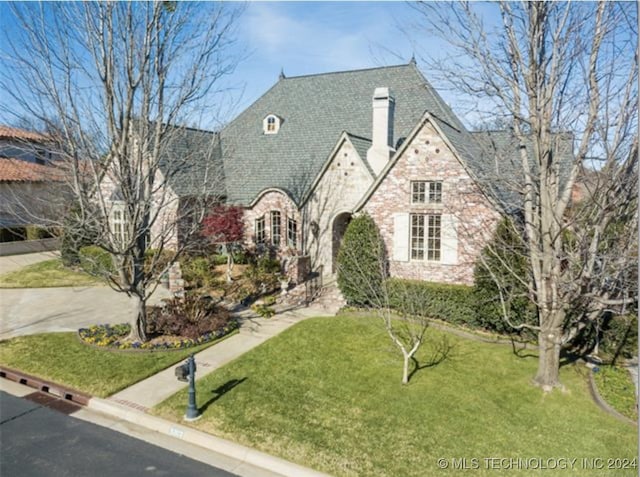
[0,126,62,240]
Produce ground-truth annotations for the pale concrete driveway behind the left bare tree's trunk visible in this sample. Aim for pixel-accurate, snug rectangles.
[0,286,169,340]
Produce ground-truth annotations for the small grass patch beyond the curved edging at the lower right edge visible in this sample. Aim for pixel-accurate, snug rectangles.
[593,366,638,421]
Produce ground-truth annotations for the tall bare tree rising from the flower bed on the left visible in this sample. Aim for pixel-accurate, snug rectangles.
[0,2,238,340]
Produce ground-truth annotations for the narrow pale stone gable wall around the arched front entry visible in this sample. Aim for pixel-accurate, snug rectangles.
[303,137,373,273]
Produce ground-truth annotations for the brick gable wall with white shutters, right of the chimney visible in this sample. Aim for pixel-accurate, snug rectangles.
[363,122,499,284]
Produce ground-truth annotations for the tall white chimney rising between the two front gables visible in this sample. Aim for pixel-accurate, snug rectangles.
[367,88,395,175]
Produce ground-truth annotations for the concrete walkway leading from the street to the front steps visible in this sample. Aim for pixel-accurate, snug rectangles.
[109,307,333,411]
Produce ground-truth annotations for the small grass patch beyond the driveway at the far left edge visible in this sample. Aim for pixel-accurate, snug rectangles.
[0,258,102,288]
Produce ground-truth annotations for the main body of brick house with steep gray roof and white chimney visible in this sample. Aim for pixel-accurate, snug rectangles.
[136,61,570,284]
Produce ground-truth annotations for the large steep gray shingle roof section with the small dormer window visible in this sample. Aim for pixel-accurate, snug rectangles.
[220,64,464,204]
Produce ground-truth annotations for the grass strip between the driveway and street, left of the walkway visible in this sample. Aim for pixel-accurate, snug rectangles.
[0,333,233,397]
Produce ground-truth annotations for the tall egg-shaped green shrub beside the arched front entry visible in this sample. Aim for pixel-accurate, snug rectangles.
[338,214,386,306]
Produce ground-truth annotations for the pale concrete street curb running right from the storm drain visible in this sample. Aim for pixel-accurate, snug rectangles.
[87,398,330,477]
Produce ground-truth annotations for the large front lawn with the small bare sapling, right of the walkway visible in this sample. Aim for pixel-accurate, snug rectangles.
[153,315,637,477]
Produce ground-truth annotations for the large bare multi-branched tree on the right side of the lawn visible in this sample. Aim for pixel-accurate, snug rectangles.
[415,1,638,390]
